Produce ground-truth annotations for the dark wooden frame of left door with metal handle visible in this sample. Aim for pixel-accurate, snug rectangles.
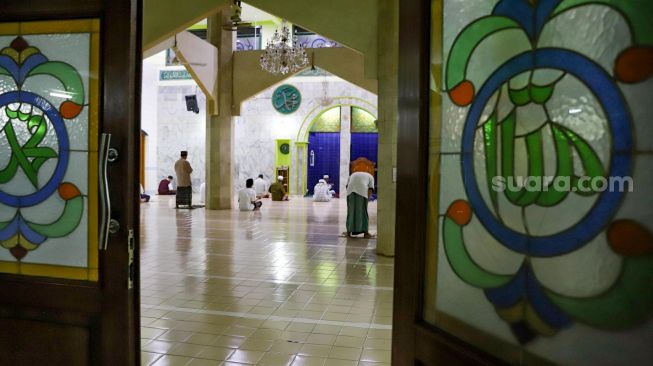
[0,0,142,365]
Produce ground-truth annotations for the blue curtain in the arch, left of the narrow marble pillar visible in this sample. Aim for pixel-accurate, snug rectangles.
[306,132,340,195]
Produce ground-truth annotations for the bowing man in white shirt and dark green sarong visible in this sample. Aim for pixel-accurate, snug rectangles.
[343,172,374,238]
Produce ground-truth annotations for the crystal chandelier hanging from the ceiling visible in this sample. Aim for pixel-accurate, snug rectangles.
[261,21,308,75]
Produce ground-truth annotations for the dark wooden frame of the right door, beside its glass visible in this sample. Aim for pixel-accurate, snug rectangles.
[392,0,502,365]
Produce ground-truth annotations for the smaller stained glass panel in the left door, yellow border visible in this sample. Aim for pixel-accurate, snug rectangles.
[0,20,100,281]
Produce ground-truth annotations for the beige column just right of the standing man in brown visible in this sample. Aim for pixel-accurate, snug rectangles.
[206,10,236,210]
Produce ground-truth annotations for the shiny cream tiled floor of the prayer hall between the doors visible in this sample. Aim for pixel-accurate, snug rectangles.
[141,197,394,366]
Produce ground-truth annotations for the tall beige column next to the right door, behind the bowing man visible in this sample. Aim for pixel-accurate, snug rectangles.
[376,0,399,256]
